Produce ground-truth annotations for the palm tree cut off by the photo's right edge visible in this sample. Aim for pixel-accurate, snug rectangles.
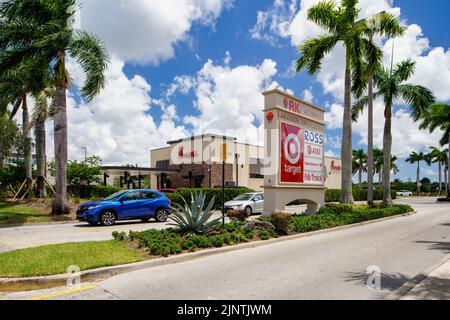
[420,103,450,197]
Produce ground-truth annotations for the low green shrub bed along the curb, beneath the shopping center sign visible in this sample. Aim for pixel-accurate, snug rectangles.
[113,204,414,256]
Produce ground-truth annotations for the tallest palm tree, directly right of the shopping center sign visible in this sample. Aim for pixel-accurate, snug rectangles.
[296,0,399,203]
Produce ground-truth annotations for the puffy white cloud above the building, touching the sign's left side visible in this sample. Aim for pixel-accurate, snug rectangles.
[184,59,279,141]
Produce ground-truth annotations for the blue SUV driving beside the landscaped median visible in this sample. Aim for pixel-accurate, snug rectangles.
[77,190,171,226]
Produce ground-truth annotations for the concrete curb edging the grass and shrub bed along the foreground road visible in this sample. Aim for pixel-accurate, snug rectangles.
[0,211,417,291]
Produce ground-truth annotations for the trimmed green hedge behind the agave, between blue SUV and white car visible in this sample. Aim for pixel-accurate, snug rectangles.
[166,188,254,209]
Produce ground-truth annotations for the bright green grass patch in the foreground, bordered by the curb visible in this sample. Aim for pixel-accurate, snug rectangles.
[0,240,144,278]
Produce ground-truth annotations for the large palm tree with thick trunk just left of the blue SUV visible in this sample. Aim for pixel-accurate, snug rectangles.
[0,0,109,214]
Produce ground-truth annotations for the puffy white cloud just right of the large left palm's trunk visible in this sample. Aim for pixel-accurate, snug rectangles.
[48,58,188,166]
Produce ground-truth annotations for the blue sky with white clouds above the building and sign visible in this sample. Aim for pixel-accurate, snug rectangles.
[60,0,450,184]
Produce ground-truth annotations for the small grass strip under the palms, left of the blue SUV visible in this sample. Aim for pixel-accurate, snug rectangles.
[0,200,65,225]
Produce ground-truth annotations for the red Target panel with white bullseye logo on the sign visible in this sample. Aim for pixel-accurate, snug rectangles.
[280,123,304,183]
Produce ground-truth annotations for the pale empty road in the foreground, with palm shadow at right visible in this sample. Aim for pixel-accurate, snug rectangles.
[1,198,450,299]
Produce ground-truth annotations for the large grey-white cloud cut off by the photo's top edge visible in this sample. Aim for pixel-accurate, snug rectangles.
[78,0,233,64]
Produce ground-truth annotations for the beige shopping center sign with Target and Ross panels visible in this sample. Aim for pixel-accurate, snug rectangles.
[263,90,325,213]
